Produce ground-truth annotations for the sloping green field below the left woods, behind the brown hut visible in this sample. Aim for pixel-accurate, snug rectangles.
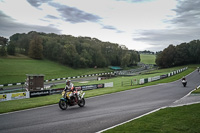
[0,57,111,84]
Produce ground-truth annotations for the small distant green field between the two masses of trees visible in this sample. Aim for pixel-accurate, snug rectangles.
[140,54,156,64]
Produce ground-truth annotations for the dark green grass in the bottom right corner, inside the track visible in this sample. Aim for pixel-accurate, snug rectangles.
[105,104,200,133]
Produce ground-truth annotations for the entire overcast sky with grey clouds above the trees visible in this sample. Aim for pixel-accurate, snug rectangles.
[0,0,200,51]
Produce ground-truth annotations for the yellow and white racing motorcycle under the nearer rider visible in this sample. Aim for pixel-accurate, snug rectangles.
[59,88,85,110]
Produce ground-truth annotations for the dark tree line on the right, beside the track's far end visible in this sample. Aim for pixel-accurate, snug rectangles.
[156,40,200,68]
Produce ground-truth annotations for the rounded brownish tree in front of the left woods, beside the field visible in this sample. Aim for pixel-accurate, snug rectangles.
[28,35,43,59]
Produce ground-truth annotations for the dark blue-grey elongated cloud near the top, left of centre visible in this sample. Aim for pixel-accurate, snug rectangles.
[49,2,101,23]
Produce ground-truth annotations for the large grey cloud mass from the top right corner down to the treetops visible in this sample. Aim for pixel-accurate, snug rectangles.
[133,0,200,51]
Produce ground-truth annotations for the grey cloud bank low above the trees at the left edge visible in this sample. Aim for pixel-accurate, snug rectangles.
[0,11,61,38]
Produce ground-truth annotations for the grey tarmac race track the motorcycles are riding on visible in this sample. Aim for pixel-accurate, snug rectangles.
[0,72,200,133]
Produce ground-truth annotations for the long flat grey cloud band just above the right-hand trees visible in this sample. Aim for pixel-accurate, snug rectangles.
[134,28,200,45]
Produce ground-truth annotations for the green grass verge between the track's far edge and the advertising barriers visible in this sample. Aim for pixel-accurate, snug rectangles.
[0,65,196,113]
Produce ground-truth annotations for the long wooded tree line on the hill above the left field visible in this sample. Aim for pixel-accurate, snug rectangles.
[0,31,140,68]
